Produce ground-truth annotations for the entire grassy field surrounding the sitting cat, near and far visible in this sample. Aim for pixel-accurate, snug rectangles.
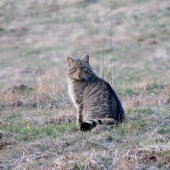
[0,0,170,170]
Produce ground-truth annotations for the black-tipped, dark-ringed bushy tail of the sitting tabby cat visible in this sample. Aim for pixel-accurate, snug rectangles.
[80,116,125,131]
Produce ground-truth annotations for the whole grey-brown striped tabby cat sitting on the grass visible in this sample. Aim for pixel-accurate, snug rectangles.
[67,54,125,131]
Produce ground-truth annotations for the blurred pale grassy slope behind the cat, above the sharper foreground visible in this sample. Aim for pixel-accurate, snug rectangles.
[0,0,170,90]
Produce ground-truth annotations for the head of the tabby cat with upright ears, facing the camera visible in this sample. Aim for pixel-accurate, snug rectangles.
[67,54,93,80]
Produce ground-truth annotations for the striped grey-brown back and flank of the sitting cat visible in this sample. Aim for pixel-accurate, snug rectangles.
[83,77,124,120]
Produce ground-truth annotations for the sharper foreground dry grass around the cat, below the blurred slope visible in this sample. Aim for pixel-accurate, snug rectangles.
[0,75,170,170]
